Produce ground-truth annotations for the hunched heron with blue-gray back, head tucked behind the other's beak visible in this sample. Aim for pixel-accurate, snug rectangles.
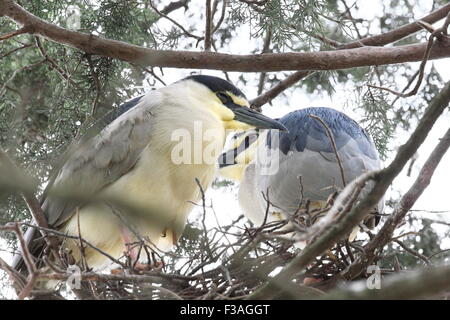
[219,108,383,247]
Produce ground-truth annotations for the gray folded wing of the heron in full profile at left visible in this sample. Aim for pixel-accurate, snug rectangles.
[43,92,159,227]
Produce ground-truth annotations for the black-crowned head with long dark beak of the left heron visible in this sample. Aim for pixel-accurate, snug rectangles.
[181,75,286,130]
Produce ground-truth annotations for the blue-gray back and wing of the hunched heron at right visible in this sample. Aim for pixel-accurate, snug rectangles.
[264,108,380,211]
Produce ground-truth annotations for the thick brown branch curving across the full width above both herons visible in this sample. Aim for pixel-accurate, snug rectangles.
[0,0,450,72]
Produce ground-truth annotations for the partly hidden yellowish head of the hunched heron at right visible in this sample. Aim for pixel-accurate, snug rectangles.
[219,129,265,181]
